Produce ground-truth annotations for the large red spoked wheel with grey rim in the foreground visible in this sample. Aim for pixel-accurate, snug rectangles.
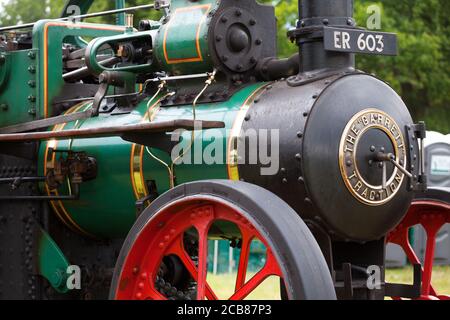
[111,181,335,300]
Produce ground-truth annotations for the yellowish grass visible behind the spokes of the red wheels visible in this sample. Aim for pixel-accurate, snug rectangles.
[208,266,450,300]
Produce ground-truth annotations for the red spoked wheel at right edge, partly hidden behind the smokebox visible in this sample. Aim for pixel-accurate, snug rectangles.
[387,189,450,300]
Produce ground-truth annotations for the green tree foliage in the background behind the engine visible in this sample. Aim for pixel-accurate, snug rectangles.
[0,0,450,133]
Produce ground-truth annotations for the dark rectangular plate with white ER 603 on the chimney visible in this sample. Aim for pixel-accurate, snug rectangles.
[324,27,397,56]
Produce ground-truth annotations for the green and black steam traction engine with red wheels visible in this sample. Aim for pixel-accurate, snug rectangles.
[0,0,449,300]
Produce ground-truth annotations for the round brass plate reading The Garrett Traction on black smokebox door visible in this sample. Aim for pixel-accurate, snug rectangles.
[339,109,407,206]
